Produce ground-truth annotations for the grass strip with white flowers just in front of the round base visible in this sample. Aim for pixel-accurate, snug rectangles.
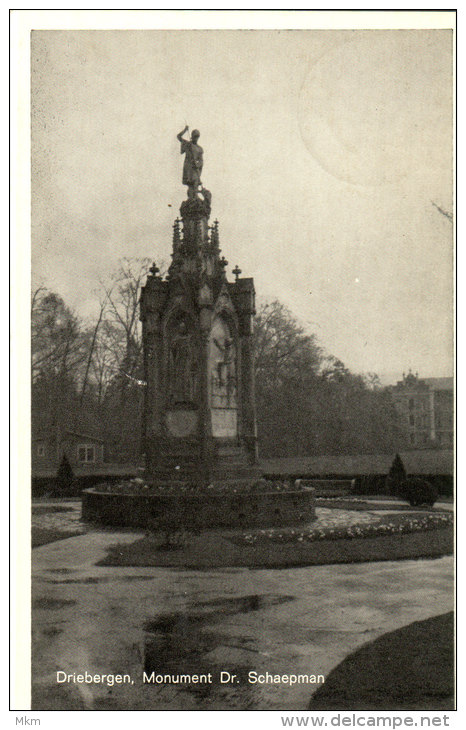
[100,513,453,568]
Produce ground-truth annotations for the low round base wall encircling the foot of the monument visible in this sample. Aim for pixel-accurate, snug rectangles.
[82,489,315,529]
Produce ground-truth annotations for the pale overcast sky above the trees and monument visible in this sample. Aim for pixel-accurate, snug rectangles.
[31,30,452,382]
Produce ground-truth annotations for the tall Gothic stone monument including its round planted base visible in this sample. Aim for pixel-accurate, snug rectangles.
[82,127,315,529]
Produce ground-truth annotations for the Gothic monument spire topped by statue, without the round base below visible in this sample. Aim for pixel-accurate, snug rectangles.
[141,127,260,487]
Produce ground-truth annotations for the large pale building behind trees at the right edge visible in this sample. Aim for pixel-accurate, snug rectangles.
[391,371,453,449]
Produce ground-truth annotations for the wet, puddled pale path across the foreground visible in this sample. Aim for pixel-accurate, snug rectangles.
[32,498,453,711]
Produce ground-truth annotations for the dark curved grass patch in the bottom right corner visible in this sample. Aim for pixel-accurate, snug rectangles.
[309,613,454,711]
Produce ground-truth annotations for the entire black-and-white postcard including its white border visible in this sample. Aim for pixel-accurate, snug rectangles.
[12,10,456,725]
